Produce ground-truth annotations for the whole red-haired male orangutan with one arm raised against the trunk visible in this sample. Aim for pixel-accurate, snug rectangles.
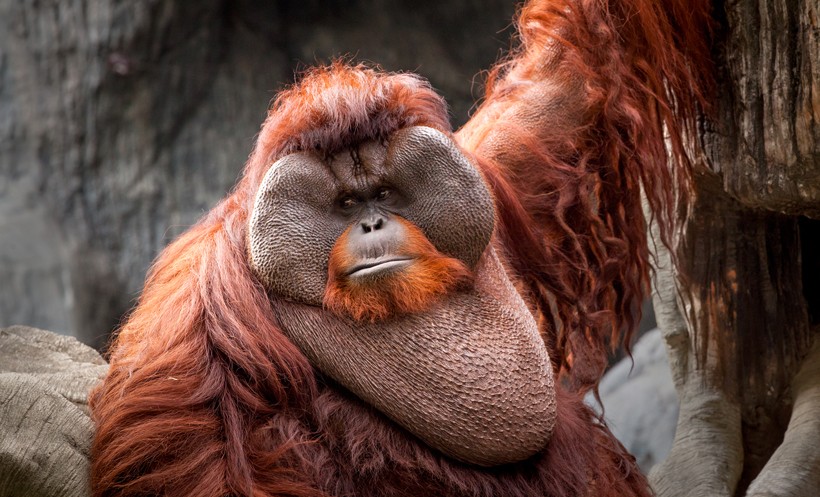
[92,0,708,497]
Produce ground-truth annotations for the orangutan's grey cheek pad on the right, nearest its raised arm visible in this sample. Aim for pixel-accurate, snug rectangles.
[387,126,495,268]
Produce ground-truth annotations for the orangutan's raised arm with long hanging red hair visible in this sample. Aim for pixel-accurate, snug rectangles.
[456,0,709,389]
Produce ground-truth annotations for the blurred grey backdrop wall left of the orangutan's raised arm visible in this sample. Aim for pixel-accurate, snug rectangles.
[0,0,514,345]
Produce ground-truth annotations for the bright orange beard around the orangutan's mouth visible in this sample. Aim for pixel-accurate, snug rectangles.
[324,218,471,322]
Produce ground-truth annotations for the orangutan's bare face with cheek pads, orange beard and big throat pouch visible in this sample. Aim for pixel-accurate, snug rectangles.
[249,127,555,465]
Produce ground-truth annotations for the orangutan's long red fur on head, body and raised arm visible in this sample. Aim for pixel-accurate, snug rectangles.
[91,0,706,497]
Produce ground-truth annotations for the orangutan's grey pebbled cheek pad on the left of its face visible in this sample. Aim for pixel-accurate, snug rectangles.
[248,153,345,305]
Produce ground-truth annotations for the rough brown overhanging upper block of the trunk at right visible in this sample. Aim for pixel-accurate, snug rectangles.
[705,0,820,218]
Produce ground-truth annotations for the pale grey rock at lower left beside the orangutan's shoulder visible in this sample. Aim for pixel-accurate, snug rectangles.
[0,326,108,497]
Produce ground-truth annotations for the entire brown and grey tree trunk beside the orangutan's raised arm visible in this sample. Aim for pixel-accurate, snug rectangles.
[651,0,820,497]
